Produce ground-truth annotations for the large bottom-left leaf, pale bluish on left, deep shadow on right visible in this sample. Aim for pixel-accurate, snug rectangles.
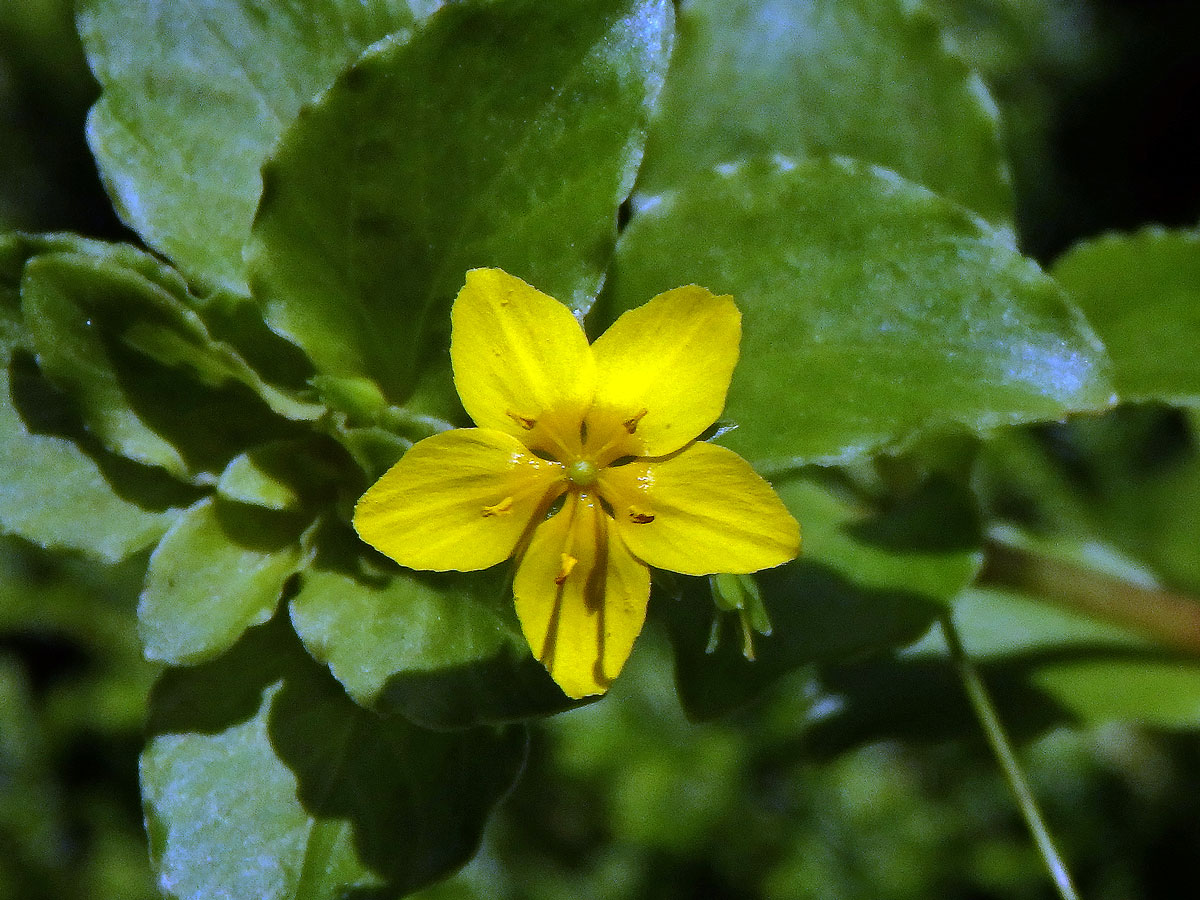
[142,619,524,900]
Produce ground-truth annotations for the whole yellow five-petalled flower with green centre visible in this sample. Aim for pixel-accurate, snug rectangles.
[354,269,800,698]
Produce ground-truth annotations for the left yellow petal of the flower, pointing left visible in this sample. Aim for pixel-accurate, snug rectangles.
[354,428,565,571]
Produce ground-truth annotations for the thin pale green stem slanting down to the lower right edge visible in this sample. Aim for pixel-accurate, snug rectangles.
[941,613,1079,900]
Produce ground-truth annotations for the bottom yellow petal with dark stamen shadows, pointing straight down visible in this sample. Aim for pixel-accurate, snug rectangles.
[512,493,650,700]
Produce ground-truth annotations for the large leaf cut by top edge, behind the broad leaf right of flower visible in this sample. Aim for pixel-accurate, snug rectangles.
[638,0,1013,223]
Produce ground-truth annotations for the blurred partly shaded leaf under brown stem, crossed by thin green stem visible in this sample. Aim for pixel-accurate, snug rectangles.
[805,578,1200,755]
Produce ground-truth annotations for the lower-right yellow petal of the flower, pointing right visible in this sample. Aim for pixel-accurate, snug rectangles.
[599,442,800,575]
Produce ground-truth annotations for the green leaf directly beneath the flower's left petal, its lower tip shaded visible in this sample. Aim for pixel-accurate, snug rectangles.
[292,529,570,728]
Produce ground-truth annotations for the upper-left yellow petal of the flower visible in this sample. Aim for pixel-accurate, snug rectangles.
[450,269,595,449]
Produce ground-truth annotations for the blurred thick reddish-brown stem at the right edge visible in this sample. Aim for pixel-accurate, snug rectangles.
[980,540,1200,654]
